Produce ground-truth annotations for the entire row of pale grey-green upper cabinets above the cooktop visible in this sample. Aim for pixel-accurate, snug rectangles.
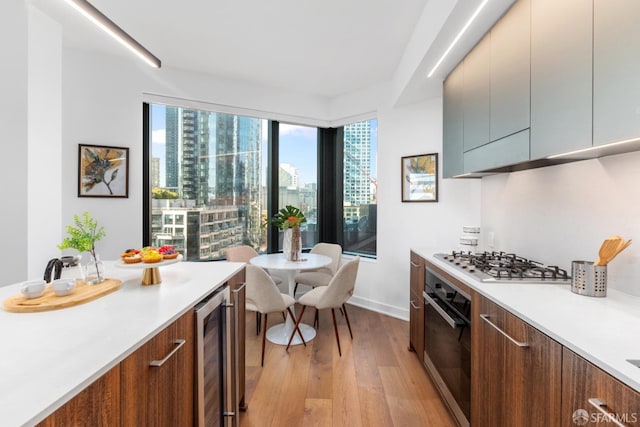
[443,0,640,177]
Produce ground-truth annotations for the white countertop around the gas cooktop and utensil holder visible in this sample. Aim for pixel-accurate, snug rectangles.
[412,248,640,392]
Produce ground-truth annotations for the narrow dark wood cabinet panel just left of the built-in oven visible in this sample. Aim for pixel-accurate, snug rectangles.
[409,252,424,362]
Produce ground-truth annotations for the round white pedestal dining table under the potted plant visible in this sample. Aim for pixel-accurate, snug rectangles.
[249,253,331,345]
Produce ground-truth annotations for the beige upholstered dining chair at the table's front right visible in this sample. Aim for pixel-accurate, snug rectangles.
[287,256,360,356]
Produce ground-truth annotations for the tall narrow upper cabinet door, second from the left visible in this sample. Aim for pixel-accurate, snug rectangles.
[463,33,491,151]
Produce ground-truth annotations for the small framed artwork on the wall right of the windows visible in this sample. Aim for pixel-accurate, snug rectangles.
[402,153,438,202]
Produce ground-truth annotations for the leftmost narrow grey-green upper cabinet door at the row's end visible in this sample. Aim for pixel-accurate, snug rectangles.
[442,63,464,178]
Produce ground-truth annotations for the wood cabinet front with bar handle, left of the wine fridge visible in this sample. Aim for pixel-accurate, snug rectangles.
[121,310,195,426]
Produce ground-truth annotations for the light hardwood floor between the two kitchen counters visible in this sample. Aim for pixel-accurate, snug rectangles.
[240,305,455,427]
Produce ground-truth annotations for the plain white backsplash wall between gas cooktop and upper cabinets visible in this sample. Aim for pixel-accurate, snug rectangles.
[482,153,640,295]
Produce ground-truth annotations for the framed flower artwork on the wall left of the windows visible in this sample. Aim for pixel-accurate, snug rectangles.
[78,144,129,197]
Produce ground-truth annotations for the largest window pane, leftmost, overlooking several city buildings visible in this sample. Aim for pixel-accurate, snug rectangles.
[150,104,267,260]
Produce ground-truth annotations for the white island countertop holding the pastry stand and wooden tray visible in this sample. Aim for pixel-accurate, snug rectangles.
[0,261,244,427]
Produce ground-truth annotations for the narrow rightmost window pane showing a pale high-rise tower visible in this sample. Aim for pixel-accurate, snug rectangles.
[343,119,378,256]
